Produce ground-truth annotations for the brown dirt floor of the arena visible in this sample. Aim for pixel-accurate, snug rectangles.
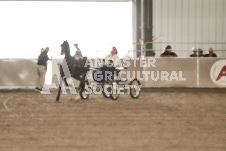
[0,88,226,151]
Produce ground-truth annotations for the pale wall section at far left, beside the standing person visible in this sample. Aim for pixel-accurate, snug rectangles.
[0,59,37,88]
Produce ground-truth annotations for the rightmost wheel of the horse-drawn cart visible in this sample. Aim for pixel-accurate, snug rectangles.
[129,79,141,99]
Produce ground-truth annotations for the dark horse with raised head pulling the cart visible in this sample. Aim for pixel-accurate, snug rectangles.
[56,41,90,101]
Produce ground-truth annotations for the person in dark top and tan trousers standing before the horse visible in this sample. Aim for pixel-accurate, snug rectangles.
[35,47,50,91]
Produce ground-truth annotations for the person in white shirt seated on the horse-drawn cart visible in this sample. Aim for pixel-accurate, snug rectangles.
[105,47,119,67]
